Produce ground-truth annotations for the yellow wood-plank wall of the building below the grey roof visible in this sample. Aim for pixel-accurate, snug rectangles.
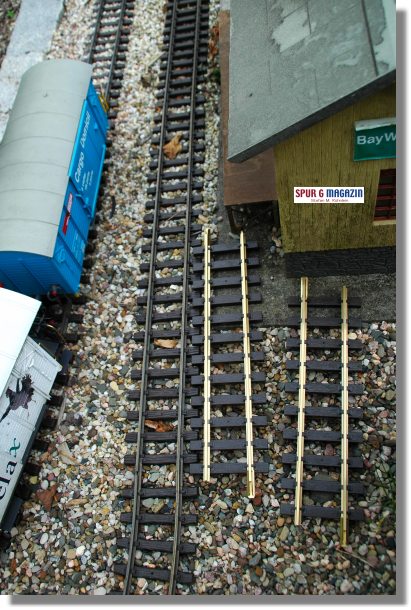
[274,85,396,252]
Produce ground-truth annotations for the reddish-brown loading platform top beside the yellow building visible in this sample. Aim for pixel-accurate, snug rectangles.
[219,11,277,205]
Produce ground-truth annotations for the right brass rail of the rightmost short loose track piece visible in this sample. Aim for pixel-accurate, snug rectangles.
[340,286,349,546]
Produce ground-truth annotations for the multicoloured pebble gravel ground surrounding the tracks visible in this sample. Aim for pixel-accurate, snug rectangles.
[0,0,396,595]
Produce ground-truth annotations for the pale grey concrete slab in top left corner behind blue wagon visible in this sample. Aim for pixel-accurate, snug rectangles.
[0,0,64,140]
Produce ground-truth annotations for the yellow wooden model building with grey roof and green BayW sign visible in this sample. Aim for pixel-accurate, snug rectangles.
[227,0,396,276]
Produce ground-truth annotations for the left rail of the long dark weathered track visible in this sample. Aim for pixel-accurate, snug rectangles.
[123,2,178,595]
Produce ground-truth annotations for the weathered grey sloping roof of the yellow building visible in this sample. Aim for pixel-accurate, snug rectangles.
[228,0,395,162]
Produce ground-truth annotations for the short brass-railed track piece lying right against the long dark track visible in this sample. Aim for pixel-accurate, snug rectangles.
[190,229,269,498]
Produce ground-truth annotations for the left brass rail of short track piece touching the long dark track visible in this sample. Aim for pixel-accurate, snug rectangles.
[203,229,211,482]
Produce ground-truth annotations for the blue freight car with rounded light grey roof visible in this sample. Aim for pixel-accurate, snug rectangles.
[0,60,108,295]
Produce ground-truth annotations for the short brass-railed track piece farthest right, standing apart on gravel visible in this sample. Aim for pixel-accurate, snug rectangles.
[280,277,364,545]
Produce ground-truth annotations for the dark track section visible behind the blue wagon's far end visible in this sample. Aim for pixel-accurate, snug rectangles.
[87,0,135,119]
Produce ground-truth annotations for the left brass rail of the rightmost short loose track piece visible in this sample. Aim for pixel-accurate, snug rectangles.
[294,277,308,525]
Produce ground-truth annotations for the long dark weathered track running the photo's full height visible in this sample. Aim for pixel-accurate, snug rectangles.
[114,0,209,594]
